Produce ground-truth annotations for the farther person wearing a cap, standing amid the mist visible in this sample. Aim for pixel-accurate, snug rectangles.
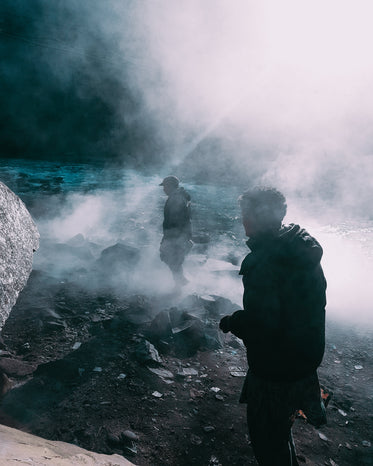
[160,175,193,288]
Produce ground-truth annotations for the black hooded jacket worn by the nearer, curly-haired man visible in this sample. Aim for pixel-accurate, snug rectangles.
[230,224,326,381]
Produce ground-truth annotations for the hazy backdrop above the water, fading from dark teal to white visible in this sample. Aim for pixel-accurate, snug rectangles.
[0,0,373,217]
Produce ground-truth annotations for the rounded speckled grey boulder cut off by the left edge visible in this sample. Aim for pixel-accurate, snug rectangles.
[0,182,39,330]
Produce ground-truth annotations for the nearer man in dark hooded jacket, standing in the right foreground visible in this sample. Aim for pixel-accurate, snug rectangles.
[220,187,326,466]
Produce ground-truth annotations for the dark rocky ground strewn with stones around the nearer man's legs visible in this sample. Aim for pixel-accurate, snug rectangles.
[0,258,373,466]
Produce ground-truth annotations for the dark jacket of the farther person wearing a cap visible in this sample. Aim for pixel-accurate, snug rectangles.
[163,187,192,240]
